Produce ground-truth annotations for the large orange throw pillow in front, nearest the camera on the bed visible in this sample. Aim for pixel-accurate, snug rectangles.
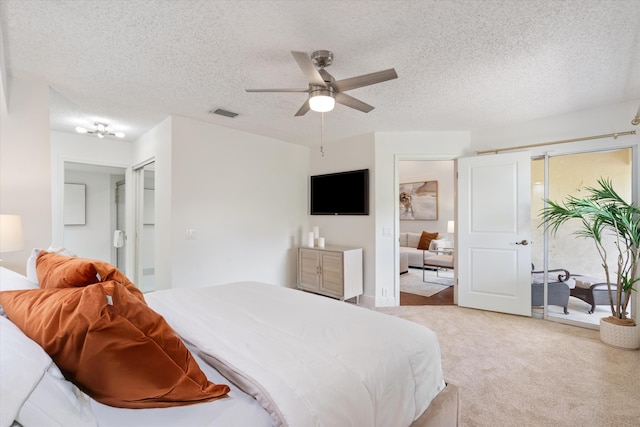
[0,281,229,408]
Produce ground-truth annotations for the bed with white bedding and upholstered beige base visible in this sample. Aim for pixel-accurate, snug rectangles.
[0,252,459,427]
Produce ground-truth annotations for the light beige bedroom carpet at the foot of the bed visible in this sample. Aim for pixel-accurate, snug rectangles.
[377,306,640,427]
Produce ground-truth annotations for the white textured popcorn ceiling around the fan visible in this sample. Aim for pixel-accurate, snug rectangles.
[0,0,640,146]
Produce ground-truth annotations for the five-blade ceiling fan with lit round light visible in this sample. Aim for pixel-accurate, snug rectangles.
[246,50,398,116]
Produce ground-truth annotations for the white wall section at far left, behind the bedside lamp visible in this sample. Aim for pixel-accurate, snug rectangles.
[0,79,51,274]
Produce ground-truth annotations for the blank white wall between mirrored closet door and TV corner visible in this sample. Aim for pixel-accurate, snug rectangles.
[169,116,309,287]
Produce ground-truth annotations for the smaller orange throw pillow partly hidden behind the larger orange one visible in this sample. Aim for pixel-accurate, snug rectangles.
[36,251,144,301]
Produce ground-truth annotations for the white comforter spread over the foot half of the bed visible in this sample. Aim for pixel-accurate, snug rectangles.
[145,282,444,427]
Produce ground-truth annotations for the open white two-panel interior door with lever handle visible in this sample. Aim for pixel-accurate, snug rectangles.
[457,152,531,316]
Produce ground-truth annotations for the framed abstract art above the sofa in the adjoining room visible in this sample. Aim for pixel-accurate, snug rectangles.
[400,181,438,221]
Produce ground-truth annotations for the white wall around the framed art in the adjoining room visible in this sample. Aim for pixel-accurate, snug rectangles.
[398,160,455,238]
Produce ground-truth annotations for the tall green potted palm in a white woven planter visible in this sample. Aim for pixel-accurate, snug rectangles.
[540,178,640,349]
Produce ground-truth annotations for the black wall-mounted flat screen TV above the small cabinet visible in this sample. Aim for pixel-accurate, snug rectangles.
[309,169,369,215]
